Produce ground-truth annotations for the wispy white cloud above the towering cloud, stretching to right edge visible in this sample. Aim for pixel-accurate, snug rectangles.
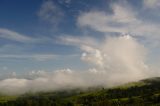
[77,3,160,39]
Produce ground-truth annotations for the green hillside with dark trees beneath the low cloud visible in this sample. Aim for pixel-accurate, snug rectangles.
[0,77,160,106]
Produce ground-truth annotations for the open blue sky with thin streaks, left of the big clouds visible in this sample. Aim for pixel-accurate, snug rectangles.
[0,0,109,73]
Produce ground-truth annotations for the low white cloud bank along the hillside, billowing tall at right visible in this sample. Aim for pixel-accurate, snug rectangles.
[0,35,150,94]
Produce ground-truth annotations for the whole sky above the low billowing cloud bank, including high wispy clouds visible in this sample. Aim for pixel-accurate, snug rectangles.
[0,0,160,73]
